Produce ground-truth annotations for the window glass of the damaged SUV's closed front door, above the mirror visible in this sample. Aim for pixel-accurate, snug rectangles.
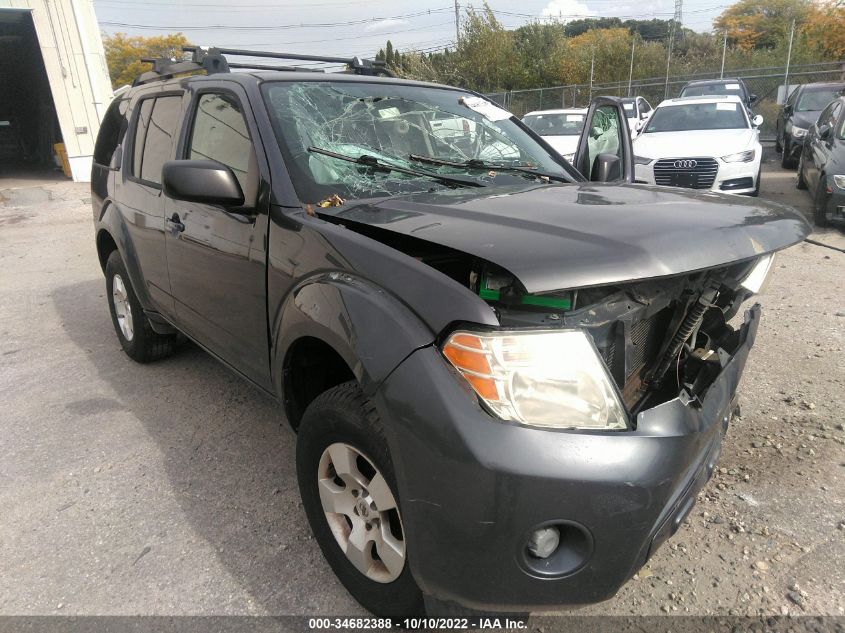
[188,93,255,196]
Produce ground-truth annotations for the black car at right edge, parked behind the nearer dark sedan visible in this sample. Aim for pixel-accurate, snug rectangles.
[775,82,845,169]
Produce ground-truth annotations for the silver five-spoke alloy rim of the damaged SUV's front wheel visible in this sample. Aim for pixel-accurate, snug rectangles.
[317,442,405,583]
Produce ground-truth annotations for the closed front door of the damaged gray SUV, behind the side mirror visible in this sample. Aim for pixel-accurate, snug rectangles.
[165,82,271,389]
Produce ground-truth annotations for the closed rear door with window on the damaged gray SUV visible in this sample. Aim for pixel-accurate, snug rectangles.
[114,91,183,318]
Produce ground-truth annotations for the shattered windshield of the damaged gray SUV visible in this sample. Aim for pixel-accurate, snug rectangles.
[263,81,573,203]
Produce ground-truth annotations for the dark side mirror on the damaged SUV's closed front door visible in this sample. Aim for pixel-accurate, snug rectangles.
[161,160,244,207]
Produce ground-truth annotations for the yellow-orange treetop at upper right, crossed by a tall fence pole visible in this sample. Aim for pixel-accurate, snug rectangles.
[713,0,810,51]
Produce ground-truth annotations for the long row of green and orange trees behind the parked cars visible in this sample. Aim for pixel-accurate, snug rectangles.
[378,0,845,92]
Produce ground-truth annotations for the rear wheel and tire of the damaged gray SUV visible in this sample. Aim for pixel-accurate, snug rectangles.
[106,251,176,363]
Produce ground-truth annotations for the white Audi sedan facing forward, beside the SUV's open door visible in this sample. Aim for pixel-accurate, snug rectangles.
[634,95,763,196]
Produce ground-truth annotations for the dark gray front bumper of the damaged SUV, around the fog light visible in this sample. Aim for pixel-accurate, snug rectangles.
[376,305,760,611]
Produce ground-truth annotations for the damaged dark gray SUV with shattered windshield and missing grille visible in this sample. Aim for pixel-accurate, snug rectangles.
[92,50,809,617]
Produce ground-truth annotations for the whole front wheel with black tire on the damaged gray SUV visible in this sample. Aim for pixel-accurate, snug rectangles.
[296,382,425,618]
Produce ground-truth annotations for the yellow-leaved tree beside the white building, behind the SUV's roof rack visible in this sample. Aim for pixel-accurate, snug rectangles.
[103,33,188,88]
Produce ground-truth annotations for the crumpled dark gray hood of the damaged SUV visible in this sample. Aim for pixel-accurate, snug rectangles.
[320,183,810,293]
